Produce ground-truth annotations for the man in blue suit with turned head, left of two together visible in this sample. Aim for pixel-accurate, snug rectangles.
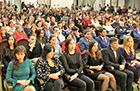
[78,30,94,52]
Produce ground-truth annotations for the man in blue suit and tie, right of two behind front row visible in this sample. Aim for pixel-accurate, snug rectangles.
[95,28,110,50]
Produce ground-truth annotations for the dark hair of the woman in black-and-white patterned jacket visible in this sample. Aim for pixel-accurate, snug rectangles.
[41,43,55,60]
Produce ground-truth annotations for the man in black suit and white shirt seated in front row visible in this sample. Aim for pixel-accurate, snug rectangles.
[103,37,134,91]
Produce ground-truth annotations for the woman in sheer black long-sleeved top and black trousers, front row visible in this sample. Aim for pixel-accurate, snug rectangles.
[61,39,94,91]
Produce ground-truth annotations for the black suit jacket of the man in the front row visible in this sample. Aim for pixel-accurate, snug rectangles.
[103,46,126,70]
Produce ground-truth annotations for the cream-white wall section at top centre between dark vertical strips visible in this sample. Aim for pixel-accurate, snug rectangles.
[51,0,73,8]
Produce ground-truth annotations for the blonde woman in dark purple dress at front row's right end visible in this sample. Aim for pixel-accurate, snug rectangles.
[120,36,140,88]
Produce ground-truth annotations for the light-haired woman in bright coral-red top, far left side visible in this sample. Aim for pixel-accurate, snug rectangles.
[13,26,28,41]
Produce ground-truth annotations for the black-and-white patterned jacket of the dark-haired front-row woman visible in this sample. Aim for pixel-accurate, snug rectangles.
[36,58,65,91]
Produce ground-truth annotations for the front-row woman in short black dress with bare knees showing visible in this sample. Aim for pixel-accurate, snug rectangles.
[83,40,116,91]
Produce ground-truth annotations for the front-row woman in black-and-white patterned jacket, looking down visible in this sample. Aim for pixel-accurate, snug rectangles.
[36,44,65,91]
